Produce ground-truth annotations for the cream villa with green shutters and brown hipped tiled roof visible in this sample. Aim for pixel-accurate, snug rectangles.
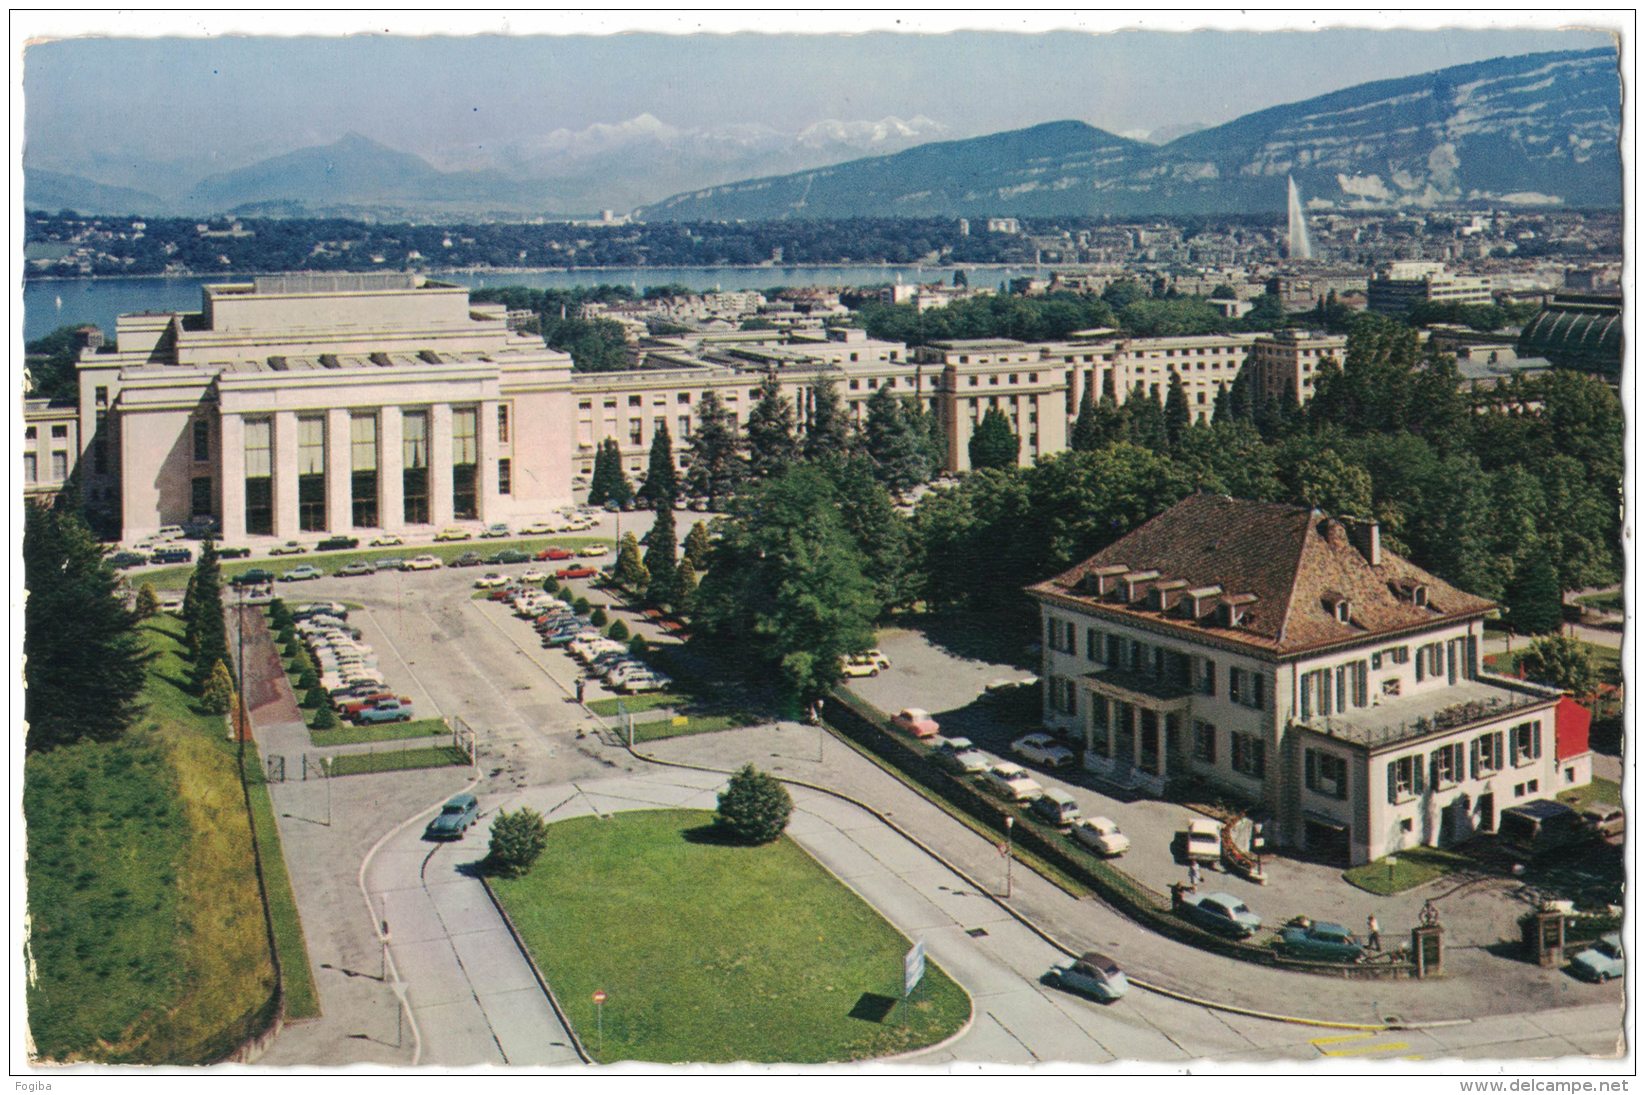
[1028,493,1582,865]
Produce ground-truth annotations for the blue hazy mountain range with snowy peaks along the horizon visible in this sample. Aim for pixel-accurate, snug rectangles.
[25,49,1622,220]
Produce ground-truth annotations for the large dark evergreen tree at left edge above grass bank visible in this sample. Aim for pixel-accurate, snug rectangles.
[23,503,151,753]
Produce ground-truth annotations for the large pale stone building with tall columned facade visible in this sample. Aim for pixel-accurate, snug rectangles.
[79,275,571,543]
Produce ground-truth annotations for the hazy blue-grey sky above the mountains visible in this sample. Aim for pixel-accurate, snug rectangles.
[23,20,1610,166]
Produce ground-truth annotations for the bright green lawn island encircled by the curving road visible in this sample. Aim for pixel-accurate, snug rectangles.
[492,811,971,1064]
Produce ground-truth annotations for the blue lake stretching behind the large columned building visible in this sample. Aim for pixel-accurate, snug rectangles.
[23,265,1035,342]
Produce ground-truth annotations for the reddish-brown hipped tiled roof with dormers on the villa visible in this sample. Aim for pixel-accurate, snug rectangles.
[1028,493,1494,654]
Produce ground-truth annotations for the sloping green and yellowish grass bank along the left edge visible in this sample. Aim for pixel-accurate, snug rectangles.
[23,617,286,1064]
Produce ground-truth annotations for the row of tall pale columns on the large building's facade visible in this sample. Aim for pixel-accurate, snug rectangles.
[219,400,503,541]
